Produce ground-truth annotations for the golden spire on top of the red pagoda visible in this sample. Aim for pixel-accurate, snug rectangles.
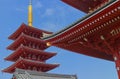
[28,0,33,26]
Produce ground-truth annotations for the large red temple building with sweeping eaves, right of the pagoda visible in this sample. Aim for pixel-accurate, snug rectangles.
[44,0,120,79]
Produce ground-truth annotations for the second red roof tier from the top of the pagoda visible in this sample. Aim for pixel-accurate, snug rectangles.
[7,33,48,50]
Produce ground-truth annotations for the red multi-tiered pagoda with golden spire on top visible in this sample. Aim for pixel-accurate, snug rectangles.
[3,0,59,75]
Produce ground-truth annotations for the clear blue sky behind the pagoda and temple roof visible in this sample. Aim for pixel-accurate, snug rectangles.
[0,0,117,79]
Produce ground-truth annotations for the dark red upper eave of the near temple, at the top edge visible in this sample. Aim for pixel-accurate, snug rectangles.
[62,0,109,13]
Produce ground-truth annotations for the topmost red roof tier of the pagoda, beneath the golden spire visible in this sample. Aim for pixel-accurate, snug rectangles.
[8,23,52,40]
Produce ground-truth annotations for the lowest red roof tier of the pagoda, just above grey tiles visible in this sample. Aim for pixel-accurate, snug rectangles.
[2,58,59,73]
